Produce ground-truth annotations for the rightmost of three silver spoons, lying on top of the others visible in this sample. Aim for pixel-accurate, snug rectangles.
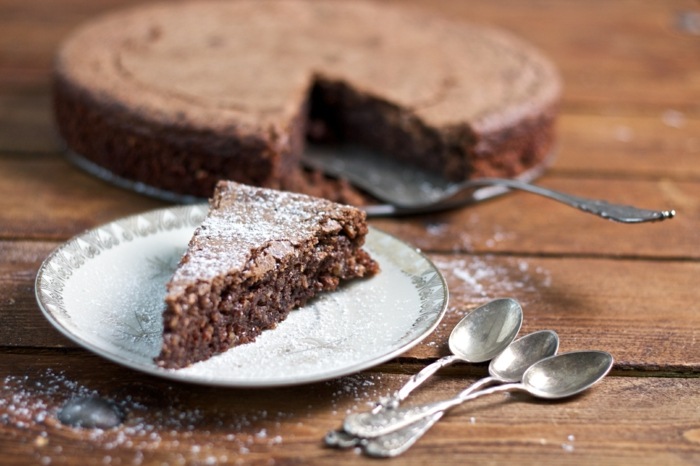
[343,351,613,438]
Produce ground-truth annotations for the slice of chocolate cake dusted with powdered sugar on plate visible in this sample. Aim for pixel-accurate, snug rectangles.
[156,181,379,369]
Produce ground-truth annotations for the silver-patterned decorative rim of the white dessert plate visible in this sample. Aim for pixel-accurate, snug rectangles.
[35,203,449,388]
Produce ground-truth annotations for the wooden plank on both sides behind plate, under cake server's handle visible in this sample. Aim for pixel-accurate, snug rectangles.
[0,155,700,251]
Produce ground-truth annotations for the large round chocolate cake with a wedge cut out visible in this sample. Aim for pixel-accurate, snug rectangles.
[54,0,561,203]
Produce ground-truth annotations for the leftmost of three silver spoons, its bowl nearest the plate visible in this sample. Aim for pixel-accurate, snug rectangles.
[324,298,523,448]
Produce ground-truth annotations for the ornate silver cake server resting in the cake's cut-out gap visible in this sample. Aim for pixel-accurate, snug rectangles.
[302,147,675,223]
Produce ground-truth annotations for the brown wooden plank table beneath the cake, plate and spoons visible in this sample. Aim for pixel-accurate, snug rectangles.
[0,0,700,465]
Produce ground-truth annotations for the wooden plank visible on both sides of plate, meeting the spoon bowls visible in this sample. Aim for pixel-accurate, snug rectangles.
[0,242,700,374]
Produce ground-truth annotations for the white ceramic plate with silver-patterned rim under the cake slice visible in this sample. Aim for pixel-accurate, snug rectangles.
[36,204,448,387]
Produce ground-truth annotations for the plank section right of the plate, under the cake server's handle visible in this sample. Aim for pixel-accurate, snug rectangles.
[373,175,700,258]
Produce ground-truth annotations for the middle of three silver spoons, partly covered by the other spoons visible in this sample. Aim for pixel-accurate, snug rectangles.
[362,330,559,458]
